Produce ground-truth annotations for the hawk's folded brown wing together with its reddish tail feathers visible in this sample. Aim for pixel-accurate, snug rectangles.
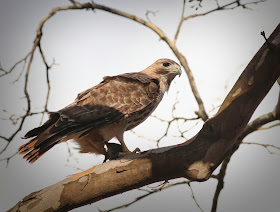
[19,73,161,162]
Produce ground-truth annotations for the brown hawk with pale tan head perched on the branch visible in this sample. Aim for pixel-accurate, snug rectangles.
[19,59,181,163]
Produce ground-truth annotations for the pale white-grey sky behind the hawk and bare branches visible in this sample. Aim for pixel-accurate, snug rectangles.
[0,0,280,211]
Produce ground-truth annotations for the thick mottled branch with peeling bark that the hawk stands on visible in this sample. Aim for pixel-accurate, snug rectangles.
[10,22,280,211]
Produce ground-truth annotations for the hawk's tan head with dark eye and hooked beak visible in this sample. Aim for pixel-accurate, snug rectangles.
[142,58,182,92]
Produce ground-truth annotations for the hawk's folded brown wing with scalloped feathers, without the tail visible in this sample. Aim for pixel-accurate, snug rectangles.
[57,73,159,133]
